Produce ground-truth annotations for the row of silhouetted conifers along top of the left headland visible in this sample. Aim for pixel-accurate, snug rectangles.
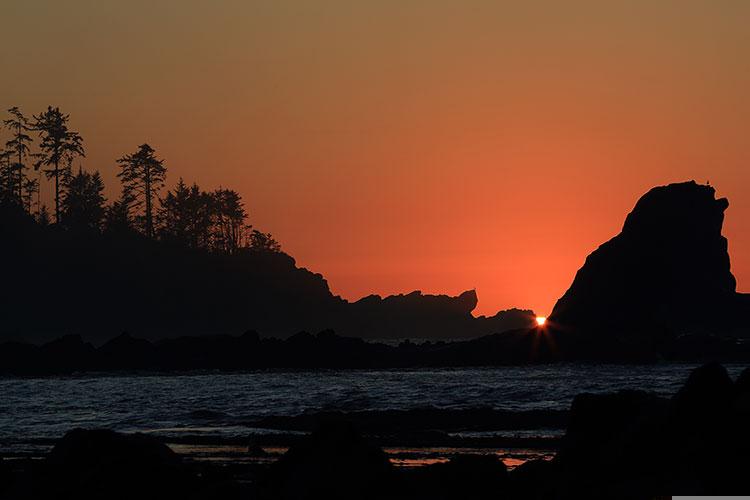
[0,106,281,254]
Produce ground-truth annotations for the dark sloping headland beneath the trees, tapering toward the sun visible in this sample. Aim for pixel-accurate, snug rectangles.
[0,199,534,343]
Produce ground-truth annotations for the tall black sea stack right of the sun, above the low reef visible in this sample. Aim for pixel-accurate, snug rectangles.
[550,181,744,337]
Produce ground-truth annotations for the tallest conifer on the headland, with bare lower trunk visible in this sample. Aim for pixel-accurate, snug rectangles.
[33,106,85,222]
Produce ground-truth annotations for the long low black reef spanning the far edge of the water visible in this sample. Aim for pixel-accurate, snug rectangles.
[0,329,750,375]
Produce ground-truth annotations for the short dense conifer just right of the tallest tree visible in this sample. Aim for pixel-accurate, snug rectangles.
[62,168,104,230]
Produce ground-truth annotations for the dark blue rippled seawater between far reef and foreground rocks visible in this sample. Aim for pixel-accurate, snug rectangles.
[0,364,744,452]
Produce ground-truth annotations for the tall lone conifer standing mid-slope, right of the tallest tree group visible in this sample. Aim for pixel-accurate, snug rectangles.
[117,144,167,238]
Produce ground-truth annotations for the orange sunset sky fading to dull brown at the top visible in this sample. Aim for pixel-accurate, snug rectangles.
[0,0,750,314]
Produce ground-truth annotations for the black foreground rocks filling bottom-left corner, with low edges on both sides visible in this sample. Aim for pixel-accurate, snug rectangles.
[0,429,254,500]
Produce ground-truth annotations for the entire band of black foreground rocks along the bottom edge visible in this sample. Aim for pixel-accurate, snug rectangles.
[0,363,750,500]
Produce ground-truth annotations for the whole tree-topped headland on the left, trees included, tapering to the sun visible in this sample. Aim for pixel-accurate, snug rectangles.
[0,106,534,343]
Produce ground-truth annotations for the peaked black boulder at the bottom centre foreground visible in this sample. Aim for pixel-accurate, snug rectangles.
[261,422,397,500]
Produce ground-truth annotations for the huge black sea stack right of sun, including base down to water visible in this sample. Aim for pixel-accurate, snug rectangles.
[547,181,750,361]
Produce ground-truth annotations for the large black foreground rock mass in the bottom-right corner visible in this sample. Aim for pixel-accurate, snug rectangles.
[554,364,750,499]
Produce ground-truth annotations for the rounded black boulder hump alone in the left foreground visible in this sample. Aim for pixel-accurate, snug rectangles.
[46,429,197,499]
